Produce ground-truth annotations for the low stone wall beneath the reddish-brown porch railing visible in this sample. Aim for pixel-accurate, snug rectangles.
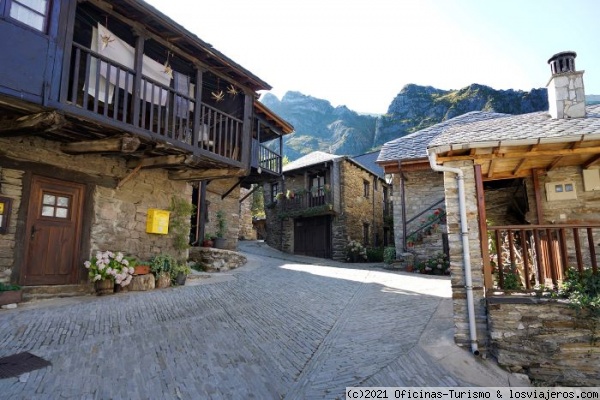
[488,297,600,386]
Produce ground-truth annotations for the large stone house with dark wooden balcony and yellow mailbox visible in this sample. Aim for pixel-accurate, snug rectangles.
[0,0,292,295]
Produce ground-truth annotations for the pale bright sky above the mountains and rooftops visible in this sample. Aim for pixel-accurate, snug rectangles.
[148,0,600,113]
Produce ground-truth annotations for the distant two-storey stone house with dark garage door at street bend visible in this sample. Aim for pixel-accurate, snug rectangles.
[264,151,391,260]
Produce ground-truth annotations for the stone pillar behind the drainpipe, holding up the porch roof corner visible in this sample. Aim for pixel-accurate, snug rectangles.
[444,161,488,351]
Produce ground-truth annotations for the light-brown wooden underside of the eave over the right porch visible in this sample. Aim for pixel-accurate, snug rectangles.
[437,139,600,181]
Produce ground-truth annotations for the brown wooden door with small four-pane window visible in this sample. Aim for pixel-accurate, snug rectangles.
[21,176,85,285]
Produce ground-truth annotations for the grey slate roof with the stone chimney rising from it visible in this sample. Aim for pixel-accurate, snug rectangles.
[429,105,600,151]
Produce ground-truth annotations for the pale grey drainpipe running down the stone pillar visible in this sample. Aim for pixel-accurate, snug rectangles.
[427,149,479,356]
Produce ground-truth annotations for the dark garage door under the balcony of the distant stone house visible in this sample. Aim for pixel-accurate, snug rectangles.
[294,215,331,258]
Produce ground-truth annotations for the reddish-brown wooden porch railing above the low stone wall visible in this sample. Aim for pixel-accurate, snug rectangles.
[482,224,600,291]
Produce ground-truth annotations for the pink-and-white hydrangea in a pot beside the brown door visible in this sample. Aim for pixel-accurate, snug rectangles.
[83,251,135,296]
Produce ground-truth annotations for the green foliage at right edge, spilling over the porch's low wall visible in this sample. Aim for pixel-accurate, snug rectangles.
[558,268,600,316]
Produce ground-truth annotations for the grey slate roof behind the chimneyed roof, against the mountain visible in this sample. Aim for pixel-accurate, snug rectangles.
[377,111,510,162]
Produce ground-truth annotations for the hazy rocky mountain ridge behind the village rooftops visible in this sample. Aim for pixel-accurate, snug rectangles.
[261,84,548,160]
